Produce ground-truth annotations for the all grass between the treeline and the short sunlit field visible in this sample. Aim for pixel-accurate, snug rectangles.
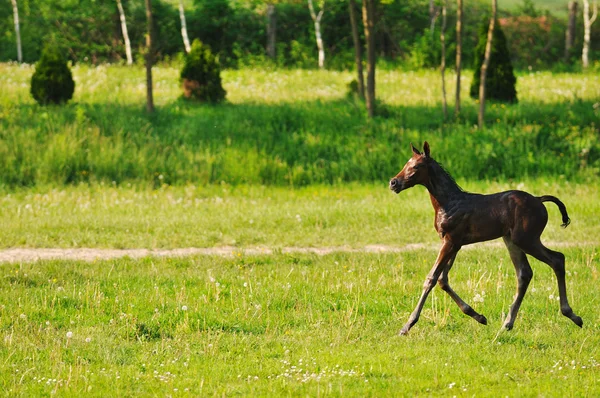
[0,65,600,187]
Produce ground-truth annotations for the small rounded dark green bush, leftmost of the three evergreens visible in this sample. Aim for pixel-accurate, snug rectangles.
[31,46,75,105]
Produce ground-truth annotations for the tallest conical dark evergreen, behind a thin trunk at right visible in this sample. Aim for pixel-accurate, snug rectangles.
[470,19,517,102]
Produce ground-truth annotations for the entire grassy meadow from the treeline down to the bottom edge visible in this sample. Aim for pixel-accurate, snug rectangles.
[0,65,600,397]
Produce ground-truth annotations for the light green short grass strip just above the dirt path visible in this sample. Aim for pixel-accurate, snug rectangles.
[0,179,600,248]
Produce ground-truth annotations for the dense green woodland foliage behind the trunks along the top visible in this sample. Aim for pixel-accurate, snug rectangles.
[0,0,600,69]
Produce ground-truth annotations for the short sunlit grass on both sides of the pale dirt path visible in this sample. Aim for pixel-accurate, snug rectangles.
[0,181,600,396]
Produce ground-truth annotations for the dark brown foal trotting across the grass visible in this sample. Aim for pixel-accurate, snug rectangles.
[390,142,583,334]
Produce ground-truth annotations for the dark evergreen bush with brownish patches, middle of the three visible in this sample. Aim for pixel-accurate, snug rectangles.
[181,40,226,102]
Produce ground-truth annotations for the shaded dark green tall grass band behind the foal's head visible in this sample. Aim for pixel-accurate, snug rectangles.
[0,99,600,186]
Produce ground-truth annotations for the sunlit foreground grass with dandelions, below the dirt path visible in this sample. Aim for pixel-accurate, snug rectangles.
[0,246,600,396]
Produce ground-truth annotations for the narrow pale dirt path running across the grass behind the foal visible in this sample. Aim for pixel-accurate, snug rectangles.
[0,242,599,263]
